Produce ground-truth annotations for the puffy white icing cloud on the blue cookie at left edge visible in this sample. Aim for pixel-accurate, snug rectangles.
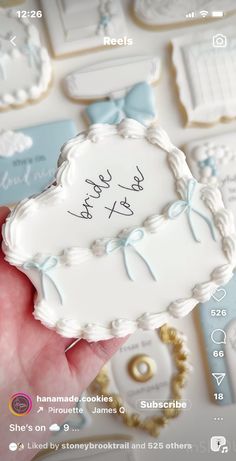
[0,130,33,158]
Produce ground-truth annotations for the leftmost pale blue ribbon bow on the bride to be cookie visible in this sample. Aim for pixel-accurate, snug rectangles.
[22,256,63,304]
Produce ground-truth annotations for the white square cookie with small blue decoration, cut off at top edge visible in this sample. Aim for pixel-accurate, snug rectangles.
[42,0,126,56]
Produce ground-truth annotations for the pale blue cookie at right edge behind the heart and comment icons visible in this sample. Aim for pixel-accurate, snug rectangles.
[198,273,236,405]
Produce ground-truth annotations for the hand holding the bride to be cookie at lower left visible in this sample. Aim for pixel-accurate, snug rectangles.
[0,204,126,461]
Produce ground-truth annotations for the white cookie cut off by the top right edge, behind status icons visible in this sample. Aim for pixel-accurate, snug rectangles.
[134,0,235,26]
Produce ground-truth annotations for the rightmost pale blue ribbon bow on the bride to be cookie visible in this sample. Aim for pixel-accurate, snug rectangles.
[167,179,216,243]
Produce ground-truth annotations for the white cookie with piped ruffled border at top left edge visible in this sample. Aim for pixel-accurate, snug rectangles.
[0,9,52,110]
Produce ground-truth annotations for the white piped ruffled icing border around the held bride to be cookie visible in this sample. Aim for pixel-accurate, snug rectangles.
[3,119,235,341]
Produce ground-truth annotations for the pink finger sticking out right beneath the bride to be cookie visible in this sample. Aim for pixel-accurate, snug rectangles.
[66,336,128,391]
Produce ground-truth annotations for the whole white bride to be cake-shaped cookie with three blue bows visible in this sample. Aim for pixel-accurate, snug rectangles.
[3,119,235,341]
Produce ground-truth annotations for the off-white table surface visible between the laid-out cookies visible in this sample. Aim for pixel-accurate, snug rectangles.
[0,0,236,461]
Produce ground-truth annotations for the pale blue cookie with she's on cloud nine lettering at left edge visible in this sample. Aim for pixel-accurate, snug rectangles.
[0,120,77,205]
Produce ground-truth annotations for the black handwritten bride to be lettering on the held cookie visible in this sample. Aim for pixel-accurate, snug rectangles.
[67,166,144,219]
